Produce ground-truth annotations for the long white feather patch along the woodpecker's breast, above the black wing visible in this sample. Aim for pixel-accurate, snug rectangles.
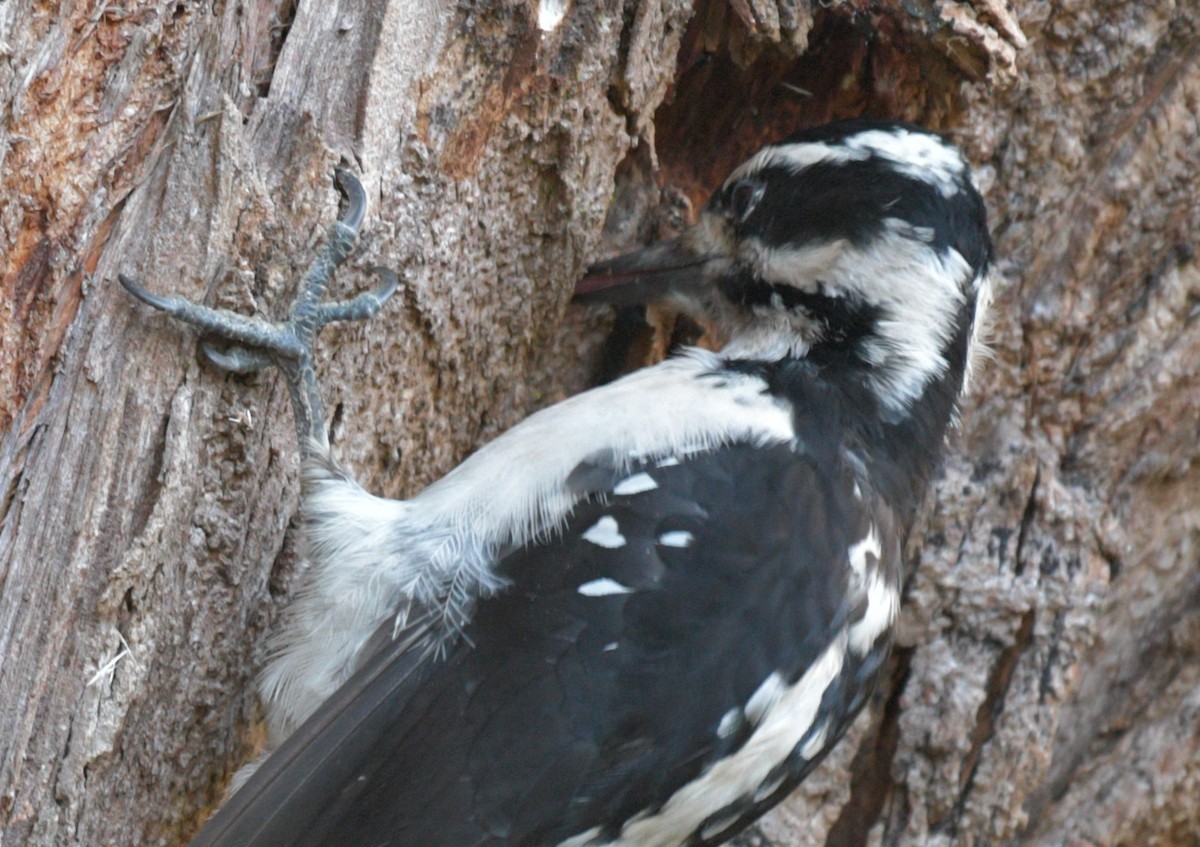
[413,349,794,546]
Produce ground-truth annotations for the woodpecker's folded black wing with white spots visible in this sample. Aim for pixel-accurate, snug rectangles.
[196,445,899,847]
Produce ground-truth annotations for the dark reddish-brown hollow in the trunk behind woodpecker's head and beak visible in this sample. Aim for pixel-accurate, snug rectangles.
[599,0,962,382]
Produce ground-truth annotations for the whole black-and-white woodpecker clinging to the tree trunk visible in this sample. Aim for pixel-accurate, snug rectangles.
[121,120,991,847]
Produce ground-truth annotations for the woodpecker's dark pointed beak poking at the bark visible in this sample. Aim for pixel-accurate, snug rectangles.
[575,239,720,306]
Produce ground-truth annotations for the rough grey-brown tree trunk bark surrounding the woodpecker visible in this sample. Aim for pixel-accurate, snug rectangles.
[0,0,1200,847]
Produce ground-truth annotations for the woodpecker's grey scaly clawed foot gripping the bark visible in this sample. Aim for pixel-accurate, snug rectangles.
[118,170,398,450]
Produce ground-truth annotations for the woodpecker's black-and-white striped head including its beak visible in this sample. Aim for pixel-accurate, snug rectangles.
[577,120,991,412]
